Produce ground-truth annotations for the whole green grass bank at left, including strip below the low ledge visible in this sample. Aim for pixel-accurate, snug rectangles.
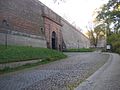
[0,45,67,74]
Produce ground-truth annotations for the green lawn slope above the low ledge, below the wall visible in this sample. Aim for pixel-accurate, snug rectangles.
[0,45,66,63]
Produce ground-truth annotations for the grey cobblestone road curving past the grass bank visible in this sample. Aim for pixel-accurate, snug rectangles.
[0,52,109,90]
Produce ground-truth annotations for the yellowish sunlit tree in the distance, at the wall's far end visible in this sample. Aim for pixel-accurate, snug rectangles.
[87,24,105,47]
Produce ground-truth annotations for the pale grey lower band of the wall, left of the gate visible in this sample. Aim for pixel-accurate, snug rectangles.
[0,33,46,48]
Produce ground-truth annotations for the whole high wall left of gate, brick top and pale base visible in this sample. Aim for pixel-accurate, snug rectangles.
[0,0,46,47]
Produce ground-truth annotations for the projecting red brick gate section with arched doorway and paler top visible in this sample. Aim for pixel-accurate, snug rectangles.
[43,6,62,51]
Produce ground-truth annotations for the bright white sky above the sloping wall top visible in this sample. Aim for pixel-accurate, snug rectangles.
[39,0,108,32]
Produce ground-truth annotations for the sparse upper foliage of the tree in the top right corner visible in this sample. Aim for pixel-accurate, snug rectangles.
[96,0,120,35]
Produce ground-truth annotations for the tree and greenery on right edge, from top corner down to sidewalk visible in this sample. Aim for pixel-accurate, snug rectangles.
[96,0,120,54]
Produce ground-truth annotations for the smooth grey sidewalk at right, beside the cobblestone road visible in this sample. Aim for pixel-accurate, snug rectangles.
[75,53,120,90]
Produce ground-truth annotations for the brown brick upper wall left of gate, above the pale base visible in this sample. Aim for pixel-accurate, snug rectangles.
[0,0,44,36]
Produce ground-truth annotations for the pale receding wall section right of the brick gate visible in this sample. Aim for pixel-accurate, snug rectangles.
[61,19,90,48]
